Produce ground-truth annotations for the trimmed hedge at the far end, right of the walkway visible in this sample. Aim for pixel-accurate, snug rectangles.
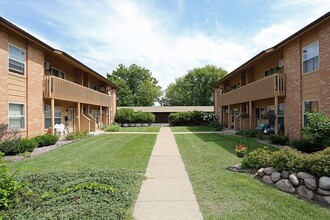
[168,111,216,126]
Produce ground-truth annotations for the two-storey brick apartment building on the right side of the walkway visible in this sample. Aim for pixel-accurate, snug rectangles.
[214,12,330,138]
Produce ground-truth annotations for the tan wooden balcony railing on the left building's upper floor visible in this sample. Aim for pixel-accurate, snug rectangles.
[44,76,112,107]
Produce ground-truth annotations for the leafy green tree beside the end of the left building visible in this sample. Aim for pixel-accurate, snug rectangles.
[107,64,162,106]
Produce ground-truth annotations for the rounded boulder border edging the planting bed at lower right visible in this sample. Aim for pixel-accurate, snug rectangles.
[255,167,330,207]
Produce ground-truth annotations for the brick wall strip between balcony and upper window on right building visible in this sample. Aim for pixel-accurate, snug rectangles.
[284,39,302,139]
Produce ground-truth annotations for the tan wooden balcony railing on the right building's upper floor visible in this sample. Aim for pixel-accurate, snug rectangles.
[218,74,285,106]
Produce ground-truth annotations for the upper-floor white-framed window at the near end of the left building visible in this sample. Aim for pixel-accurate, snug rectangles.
[8,44,25,76]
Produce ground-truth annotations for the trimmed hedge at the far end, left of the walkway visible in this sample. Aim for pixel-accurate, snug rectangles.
[115,108,155,126]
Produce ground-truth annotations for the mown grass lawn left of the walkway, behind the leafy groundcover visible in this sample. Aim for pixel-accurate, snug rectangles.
[10,134,157,173]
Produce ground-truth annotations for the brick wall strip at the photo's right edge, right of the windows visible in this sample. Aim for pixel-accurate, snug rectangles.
[319,21,330,115]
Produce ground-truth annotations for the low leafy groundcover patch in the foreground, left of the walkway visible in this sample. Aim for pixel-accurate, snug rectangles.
[4,170,143,219]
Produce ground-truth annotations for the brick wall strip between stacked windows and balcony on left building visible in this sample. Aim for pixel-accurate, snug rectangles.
[26,43,44,137]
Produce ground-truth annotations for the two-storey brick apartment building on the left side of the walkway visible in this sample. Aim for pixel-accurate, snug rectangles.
[0,17,116,137]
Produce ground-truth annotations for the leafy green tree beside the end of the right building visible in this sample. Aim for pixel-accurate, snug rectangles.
[162,65,227,106]
